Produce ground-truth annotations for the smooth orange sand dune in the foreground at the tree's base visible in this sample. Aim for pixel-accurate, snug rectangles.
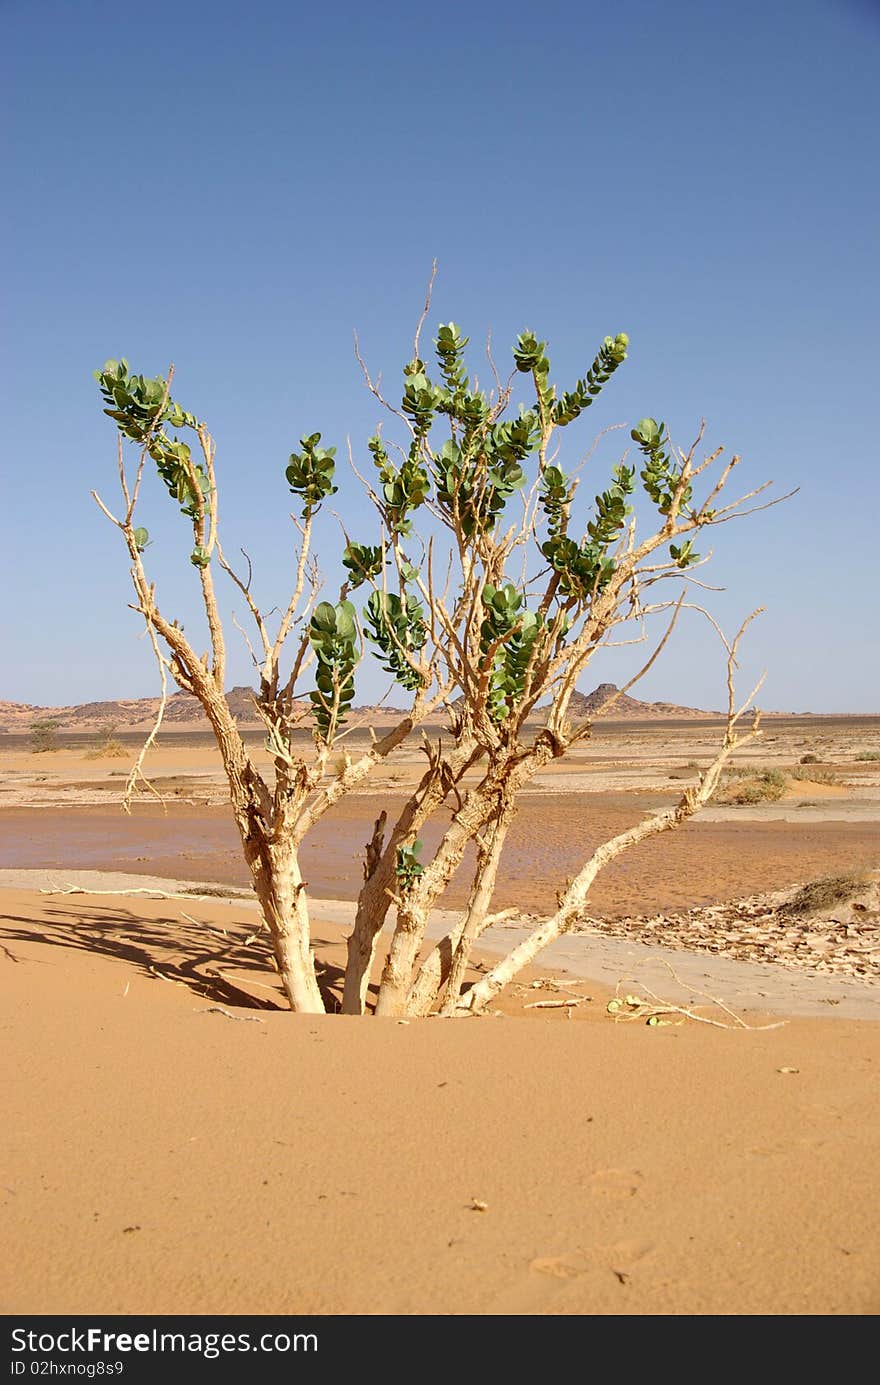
[0,889,880,1314]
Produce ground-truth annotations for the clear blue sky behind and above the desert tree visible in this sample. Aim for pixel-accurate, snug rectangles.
[0,0,880,712]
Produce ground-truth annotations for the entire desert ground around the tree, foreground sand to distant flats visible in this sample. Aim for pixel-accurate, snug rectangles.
[0,717,880,1316]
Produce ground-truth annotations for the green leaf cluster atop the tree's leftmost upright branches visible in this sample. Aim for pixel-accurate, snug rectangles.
[94,357,211,568]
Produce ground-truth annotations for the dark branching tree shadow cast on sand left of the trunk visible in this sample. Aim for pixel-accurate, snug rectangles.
[0,902,350,1012]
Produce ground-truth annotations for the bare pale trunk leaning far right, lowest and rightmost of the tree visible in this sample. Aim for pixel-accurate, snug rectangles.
[455,724,757,1015]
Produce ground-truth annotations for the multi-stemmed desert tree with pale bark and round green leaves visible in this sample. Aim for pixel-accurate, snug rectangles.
[96,303,764,1015]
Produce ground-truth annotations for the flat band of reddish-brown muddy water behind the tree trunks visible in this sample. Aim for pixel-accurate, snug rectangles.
[0,794,877,914]
